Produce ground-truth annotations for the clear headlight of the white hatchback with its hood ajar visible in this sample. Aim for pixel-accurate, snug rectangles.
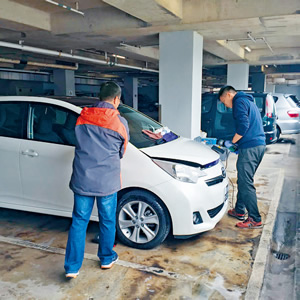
[152,159,207,183]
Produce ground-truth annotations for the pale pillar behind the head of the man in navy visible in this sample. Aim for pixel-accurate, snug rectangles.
[227,64,249,90]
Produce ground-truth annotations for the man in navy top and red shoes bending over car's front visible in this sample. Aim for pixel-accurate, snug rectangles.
[219,86,266,229]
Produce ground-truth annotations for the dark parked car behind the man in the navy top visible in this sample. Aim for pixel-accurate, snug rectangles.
[201,92,277,144]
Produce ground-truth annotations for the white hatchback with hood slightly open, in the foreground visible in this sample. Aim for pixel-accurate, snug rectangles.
[0,96,228,249]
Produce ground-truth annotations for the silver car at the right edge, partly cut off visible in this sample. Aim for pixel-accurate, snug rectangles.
[272,93,300,138]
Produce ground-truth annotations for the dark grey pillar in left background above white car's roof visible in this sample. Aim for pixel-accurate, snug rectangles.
[53,69,75,96]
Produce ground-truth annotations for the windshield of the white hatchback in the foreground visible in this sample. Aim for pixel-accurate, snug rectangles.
[118,105,178,148]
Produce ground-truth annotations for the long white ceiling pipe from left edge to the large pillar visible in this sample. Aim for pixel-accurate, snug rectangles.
[0,41,159,73]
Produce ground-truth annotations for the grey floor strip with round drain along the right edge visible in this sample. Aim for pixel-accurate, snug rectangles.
[261,135,300,300]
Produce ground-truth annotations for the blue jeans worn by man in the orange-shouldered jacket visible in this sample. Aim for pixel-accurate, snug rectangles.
[65,193,117,273]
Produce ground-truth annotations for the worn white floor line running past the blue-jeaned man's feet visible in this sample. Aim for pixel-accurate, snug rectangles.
[0,235,199,282]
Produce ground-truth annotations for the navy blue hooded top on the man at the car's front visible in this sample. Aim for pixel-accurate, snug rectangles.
[232,92,266,149]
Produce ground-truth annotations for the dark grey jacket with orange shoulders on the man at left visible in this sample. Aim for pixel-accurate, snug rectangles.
[70,102,129,196]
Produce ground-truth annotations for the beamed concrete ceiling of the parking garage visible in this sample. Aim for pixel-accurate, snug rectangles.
[0,0,300,78]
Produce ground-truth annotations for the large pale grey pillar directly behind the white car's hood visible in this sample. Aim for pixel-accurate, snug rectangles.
[159,31,203,138]
